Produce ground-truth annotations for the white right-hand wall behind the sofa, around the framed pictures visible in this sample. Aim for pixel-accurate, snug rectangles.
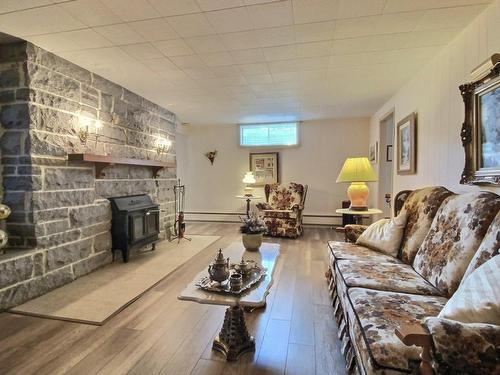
[370,0,500,206]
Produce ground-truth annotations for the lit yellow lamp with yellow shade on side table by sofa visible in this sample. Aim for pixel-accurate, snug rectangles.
[337,158,378,211]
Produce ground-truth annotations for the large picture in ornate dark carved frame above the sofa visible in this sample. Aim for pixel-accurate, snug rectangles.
[460,54,500,186]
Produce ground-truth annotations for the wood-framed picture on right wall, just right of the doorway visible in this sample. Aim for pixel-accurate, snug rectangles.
[397,113,417,175]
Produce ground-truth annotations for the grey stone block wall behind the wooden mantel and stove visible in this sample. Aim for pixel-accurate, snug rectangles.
[0,42,176,310]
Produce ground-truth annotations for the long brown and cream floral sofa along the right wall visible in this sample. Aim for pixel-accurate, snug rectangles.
[326,187,500,374]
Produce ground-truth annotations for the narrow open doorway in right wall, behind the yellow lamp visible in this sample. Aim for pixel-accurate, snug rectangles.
[378,112,395,217]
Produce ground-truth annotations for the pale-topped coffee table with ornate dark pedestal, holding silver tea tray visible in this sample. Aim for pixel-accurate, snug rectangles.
[177,242,280,361]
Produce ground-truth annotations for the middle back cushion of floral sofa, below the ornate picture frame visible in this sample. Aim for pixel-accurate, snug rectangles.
[413,192,500,297]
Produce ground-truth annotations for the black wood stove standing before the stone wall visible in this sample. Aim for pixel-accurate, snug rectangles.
[109,194,160,263]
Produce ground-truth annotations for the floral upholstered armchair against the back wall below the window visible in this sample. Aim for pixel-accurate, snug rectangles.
[257,182,307,238]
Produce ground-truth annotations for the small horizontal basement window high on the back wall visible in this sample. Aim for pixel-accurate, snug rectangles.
[240,122,299,147]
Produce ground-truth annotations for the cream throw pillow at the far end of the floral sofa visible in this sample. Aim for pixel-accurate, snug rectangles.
[356,212,407,257]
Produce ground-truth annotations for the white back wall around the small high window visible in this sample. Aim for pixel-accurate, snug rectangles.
[176,118,369,223]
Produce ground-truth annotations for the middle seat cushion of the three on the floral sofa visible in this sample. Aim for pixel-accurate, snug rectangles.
[337,260,441,296]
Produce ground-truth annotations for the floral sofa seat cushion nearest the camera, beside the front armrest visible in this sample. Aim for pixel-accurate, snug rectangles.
[348,288,446,373]
